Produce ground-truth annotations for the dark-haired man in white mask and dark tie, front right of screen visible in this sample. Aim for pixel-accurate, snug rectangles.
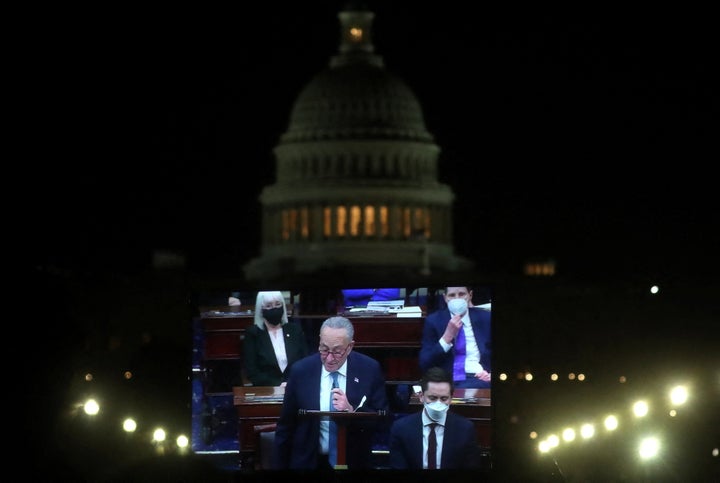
[389,367,480,469]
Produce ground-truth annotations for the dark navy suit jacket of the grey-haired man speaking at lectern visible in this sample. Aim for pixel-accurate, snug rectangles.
[273,350,388,470]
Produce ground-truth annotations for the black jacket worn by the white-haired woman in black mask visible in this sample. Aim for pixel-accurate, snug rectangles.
[243,322,308,386]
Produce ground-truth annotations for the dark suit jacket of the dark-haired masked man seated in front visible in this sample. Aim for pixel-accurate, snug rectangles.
[389,406,480,470]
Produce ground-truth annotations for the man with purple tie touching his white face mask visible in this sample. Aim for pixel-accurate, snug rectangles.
[419,287,492,388]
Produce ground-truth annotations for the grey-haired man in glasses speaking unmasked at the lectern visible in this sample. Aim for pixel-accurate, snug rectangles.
[273,317,388,470]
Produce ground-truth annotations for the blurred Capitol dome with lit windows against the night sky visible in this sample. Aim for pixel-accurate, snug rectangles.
[244,4,472,280]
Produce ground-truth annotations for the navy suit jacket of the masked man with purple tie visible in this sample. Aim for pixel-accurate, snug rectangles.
[419,307,492,374]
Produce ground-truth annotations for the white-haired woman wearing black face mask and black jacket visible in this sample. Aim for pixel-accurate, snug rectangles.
[243,291,308,386]
